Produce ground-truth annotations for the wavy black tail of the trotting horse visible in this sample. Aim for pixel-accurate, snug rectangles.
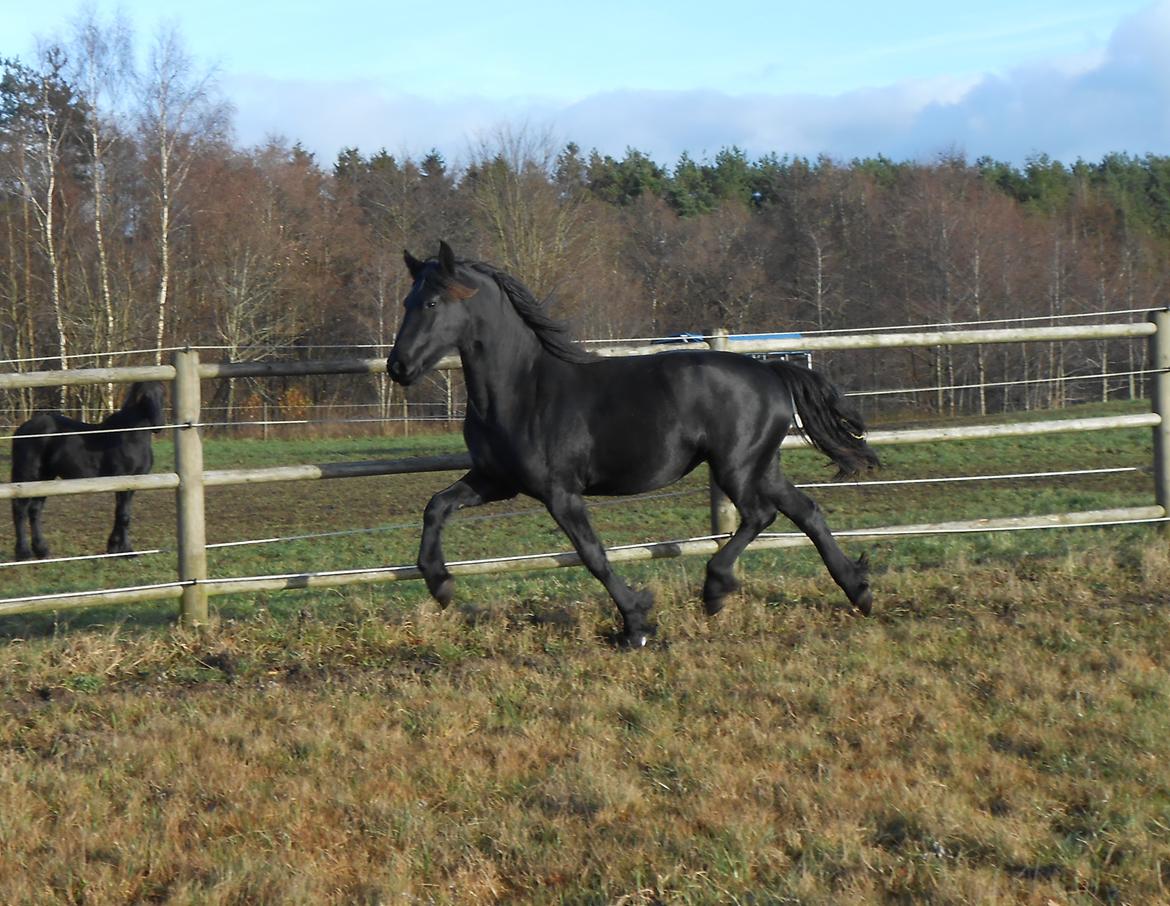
[768,359,881,479]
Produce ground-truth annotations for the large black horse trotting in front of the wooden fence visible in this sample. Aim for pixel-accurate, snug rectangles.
[386,242,878,647]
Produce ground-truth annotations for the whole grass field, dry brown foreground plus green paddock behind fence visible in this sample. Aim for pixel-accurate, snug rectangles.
[0,407,1170,906]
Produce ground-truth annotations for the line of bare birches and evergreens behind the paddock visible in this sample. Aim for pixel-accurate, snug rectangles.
[0,16,1170,426]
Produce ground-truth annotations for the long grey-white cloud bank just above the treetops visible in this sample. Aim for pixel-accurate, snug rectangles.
[228,0,1170,164]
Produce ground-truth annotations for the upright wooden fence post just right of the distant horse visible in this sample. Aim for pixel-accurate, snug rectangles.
[174,349,207,626]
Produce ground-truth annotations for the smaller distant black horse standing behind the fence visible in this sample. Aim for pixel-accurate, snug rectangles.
[12,380,166,560]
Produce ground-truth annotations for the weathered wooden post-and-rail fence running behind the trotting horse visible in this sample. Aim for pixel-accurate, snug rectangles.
[0,309,1170,624]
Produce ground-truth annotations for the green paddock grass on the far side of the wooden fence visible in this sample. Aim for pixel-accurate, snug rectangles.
[0,404,1152,622]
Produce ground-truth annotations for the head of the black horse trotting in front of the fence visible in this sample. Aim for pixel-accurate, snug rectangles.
[386,242,477,386]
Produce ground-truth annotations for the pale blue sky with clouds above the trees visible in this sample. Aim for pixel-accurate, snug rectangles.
[0,0,1170,164]
